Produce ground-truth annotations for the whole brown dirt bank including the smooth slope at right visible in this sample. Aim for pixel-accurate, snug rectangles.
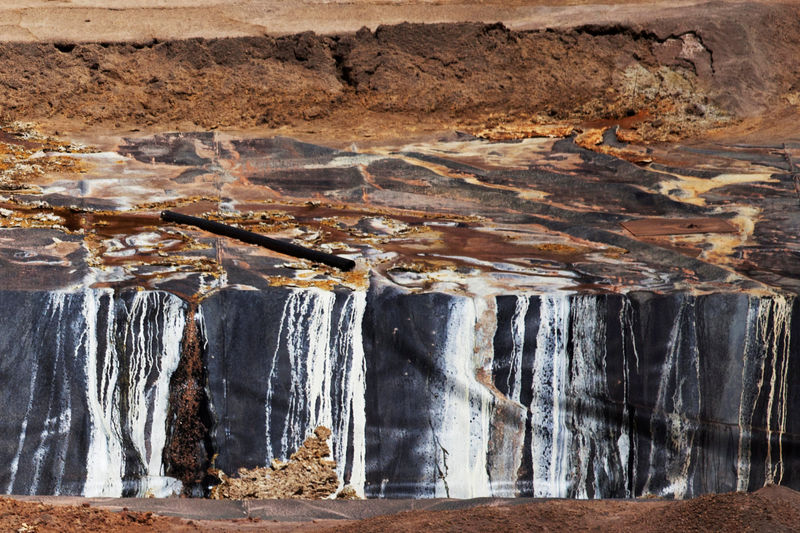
[0,3,800,140]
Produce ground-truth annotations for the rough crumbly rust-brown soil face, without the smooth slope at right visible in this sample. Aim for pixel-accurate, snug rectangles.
[0,24,712,139]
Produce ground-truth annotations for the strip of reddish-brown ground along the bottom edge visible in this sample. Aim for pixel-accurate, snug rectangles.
[9,486,800,533]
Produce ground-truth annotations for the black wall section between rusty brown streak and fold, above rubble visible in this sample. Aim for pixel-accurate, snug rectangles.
[201,288,367,490]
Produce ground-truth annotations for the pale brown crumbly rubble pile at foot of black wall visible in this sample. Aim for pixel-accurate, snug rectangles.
[211,426,339,500]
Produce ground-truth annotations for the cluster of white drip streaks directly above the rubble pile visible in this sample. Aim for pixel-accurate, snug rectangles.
[265,289,366,496]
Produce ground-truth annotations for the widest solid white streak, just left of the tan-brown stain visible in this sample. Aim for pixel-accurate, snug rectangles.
[431,297,491,498]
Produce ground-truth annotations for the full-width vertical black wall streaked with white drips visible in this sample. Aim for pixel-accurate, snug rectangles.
[0,279,800,498]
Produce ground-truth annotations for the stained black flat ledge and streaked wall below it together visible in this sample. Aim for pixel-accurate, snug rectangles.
[0,127,800,498]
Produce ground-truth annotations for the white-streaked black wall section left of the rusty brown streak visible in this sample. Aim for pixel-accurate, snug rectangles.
[0,290,186,496]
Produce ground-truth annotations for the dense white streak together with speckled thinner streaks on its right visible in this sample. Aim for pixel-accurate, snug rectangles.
[515,295,630,498]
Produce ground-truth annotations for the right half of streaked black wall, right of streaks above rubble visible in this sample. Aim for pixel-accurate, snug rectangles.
[364,284,796,498]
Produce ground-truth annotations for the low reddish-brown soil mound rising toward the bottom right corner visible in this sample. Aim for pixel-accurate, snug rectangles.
[322,487,800,533]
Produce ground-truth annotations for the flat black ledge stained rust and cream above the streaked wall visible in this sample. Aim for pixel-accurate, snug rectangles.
[1,130,800,294]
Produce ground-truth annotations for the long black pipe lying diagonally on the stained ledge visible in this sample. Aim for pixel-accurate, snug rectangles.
[161,211,356,271]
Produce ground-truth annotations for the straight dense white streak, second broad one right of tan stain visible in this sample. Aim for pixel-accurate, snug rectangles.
[530,296,570,497]
